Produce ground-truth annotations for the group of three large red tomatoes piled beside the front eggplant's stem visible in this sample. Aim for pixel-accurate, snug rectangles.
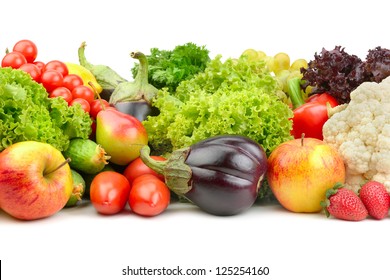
[90,156,170,217]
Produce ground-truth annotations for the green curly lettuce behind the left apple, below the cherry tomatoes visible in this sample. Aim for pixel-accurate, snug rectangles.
[0,67,92,151]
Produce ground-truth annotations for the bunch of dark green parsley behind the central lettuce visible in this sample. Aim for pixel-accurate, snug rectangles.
[131,42,210,91]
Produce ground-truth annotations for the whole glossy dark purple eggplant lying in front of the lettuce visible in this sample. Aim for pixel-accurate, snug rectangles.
[140,135,267,216]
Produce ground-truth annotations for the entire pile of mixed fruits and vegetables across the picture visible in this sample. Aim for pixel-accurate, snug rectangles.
[0,39,390,221]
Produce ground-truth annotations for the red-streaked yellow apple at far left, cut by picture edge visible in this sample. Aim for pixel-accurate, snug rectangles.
[0,141,73,220]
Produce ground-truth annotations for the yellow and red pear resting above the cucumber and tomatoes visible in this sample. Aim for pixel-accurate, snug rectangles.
[96,109,148,165]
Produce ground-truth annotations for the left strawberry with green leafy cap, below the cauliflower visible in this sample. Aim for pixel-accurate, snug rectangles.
[321,183,368,221]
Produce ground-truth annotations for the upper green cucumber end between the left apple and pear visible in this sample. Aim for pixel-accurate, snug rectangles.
[63,138,110,174]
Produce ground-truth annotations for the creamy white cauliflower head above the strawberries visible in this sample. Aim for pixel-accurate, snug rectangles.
[323,77,390,192]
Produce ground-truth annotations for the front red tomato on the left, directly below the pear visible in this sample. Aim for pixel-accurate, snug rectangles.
[89,171,130,215]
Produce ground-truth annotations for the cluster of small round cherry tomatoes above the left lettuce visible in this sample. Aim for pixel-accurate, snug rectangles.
[1,40,109,118]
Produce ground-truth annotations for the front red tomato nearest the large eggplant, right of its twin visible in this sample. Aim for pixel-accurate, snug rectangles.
[129,174,171,217]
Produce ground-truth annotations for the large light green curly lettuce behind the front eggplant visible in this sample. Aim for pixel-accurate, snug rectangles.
[143,56,293,155]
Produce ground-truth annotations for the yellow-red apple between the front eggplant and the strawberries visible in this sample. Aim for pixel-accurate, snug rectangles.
[267,138,345,213]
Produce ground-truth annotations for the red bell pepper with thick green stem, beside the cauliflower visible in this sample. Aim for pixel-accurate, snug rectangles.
[289,78,339,140]
